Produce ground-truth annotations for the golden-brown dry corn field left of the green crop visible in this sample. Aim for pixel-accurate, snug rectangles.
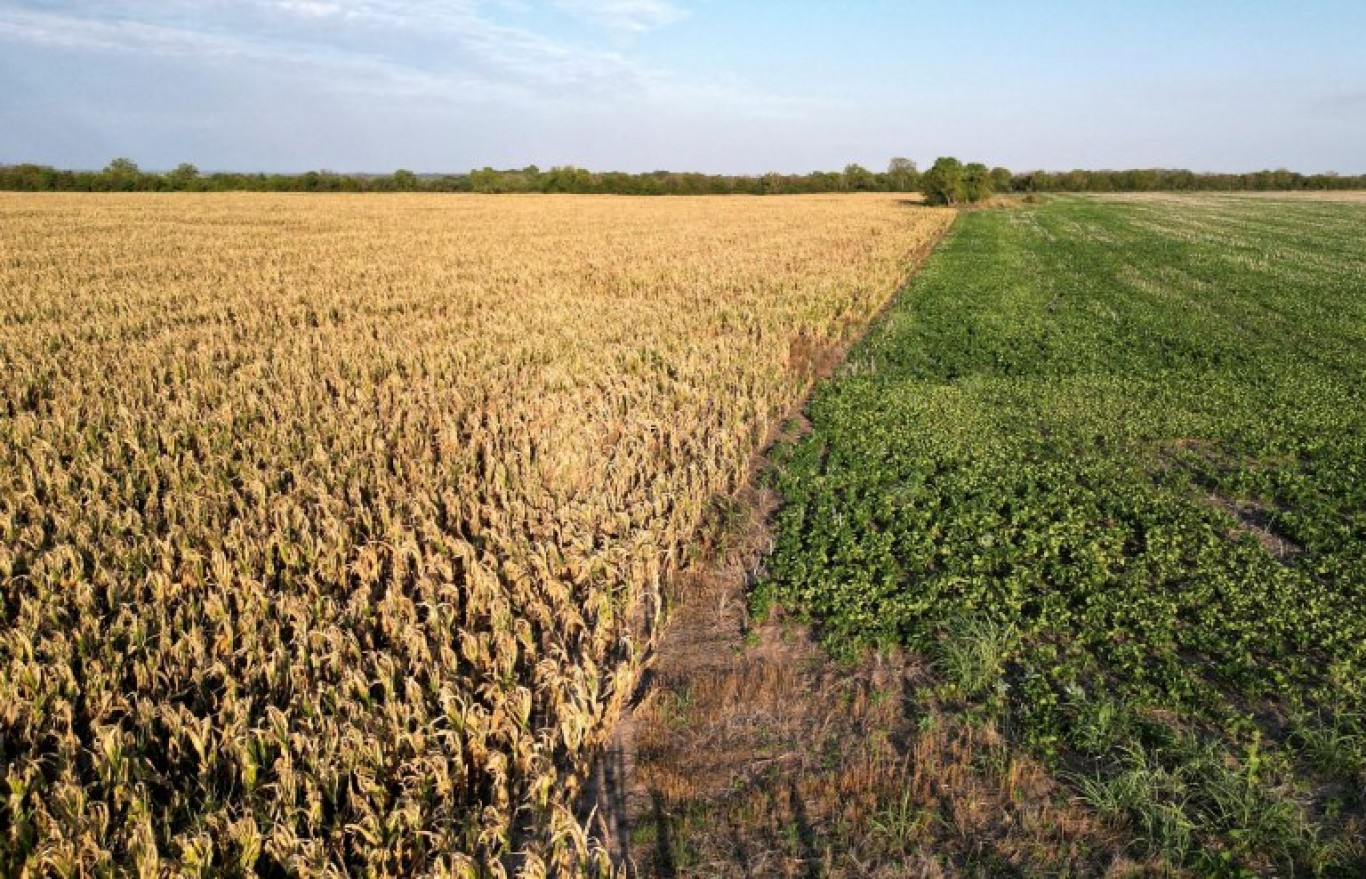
[0,194,951,876]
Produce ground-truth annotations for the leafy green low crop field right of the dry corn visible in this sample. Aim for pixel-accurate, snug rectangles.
[754,195,1366,876]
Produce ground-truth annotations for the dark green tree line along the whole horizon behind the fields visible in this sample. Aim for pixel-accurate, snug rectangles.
[0,157,1366,204]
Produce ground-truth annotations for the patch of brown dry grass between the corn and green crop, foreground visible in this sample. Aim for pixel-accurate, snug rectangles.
[609,492,1163,879]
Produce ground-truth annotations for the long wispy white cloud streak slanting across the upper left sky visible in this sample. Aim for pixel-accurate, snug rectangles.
[0,0,646,100]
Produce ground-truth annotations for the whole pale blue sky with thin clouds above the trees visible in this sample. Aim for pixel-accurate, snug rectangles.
[0,0,1366,174]
